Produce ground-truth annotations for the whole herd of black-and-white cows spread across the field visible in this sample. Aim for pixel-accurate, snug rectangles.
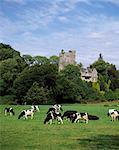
[4,104,119,124]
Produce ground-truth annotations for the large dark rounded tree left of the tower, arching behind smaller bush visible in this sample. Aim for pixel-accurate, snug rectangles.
[13,64,58,99]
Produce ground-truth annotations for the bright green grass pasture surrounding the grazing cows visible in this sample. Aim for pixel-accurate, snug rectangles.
[0,102,119,150]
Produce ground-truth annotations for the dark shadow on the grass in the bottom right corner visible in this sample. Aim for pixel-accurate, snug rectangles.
[77,135,119,150]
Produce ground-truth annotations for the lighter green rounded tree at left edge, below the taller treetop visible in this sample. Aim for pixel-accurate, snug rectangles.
[0,57,26,95]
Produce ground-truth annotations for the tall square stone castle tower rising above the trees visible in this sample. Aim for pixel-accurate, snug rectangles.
[59,50,76,71]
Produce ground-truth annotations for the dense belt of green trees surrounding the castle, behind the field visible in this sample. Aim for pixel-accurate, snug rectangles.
[0,43,119,104]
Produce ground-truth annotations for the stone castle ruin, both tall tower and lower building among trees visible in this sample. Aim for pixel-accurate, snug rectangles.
[59,50,98,82]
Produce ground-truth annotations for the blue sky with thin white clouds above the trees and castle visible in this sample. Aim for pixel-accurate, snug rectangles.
[0,0,119,69]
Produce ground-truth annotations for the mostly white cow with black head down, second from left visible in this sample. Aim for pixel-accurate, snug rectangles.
[18,109,34,119]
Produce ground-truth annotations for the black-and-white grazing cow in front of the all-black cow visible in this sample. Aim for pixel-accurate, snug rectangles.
[72,112,89,124]
